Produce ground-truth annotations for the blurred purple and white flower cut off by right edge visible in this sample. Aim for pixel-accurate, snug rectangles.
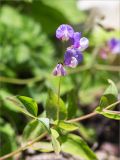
[108,38,120,54]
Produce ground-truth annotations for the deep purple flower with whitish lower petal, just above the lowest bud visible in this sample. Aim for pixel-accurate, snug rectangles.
[64,48,83,68]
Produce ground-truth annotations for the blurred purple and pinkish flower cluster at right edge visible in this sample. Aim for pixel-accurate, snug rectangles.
[100,38,120,59]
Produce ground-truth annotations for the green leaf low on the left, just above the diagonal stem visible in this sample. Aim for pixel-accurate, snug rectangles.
[23,120,45,141]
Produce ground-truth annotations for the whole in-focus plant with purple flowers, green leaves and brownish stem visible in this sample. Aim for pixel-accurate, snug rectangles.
[0,24,120,160]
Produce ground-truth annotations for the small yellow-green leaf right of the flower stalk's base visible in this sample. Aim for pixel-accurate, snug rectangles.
[59,121,78,131]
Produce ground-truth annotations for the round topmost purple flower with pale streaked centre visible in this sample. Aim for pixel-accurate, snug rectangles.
[56,24,74,41]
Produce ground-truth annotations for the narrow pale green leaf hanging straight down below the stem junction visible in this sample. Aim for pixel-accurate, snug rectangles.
[51,129,61,153]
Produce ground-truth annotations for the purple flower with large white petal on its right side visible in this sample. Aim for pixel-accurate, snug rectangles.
[72,32,89,51]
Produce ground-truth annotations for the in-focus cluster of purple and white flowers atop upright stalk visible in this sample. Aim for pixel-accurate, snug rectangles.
[53,24,89,76]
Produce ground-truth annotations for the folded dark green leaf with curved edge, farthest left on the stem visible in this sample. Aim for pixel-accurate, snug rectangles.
[17,96,38,116]
